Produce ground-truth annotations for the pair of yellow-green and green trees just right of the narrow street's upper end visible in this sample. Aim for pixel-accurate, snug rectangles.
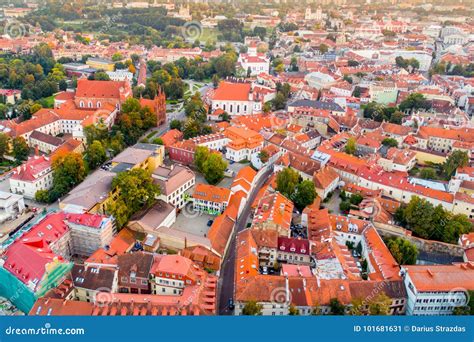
[277,167,317,211]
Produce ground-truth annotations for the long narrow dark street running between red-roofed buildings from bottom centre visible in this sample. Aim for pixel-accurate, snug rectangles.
[218,169,273,315]
